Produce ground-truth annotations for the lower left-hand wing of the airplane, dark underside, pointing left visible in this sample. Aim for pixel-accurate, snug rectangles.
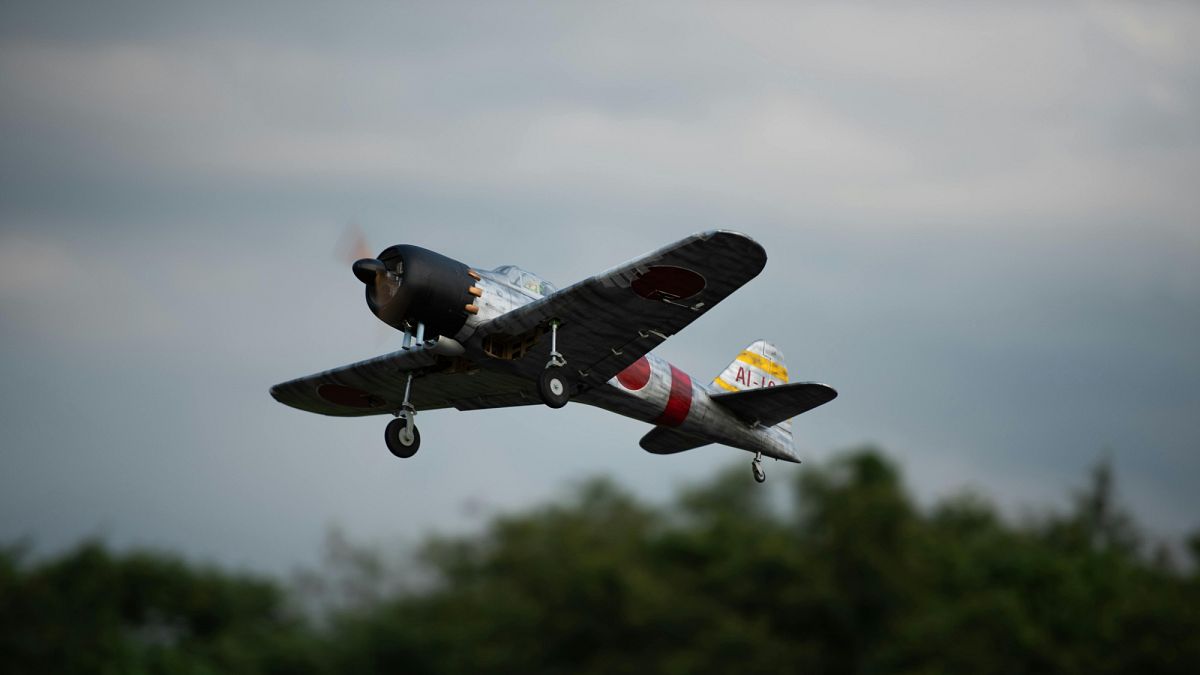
[271,346,540,417]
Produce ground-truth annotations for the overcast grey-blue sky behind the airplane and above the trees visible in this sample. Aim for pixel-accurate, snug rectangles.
[0,2,1200,571]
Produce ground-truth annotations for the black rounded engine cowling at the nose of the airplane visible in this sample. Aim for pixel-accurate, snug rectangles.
[354,244,480,339]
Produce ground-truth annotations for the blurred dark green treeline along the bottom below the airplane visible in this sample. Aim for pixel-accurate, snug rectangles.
[0,449,1200,675]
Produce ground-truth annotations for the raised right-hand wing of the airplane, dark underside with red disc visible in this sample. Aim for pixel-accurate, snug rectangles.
[478,231,767,386]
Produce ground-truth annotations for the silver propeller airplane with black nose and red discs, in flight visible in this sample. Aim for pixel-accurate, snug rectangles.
[270,231,838,483]
